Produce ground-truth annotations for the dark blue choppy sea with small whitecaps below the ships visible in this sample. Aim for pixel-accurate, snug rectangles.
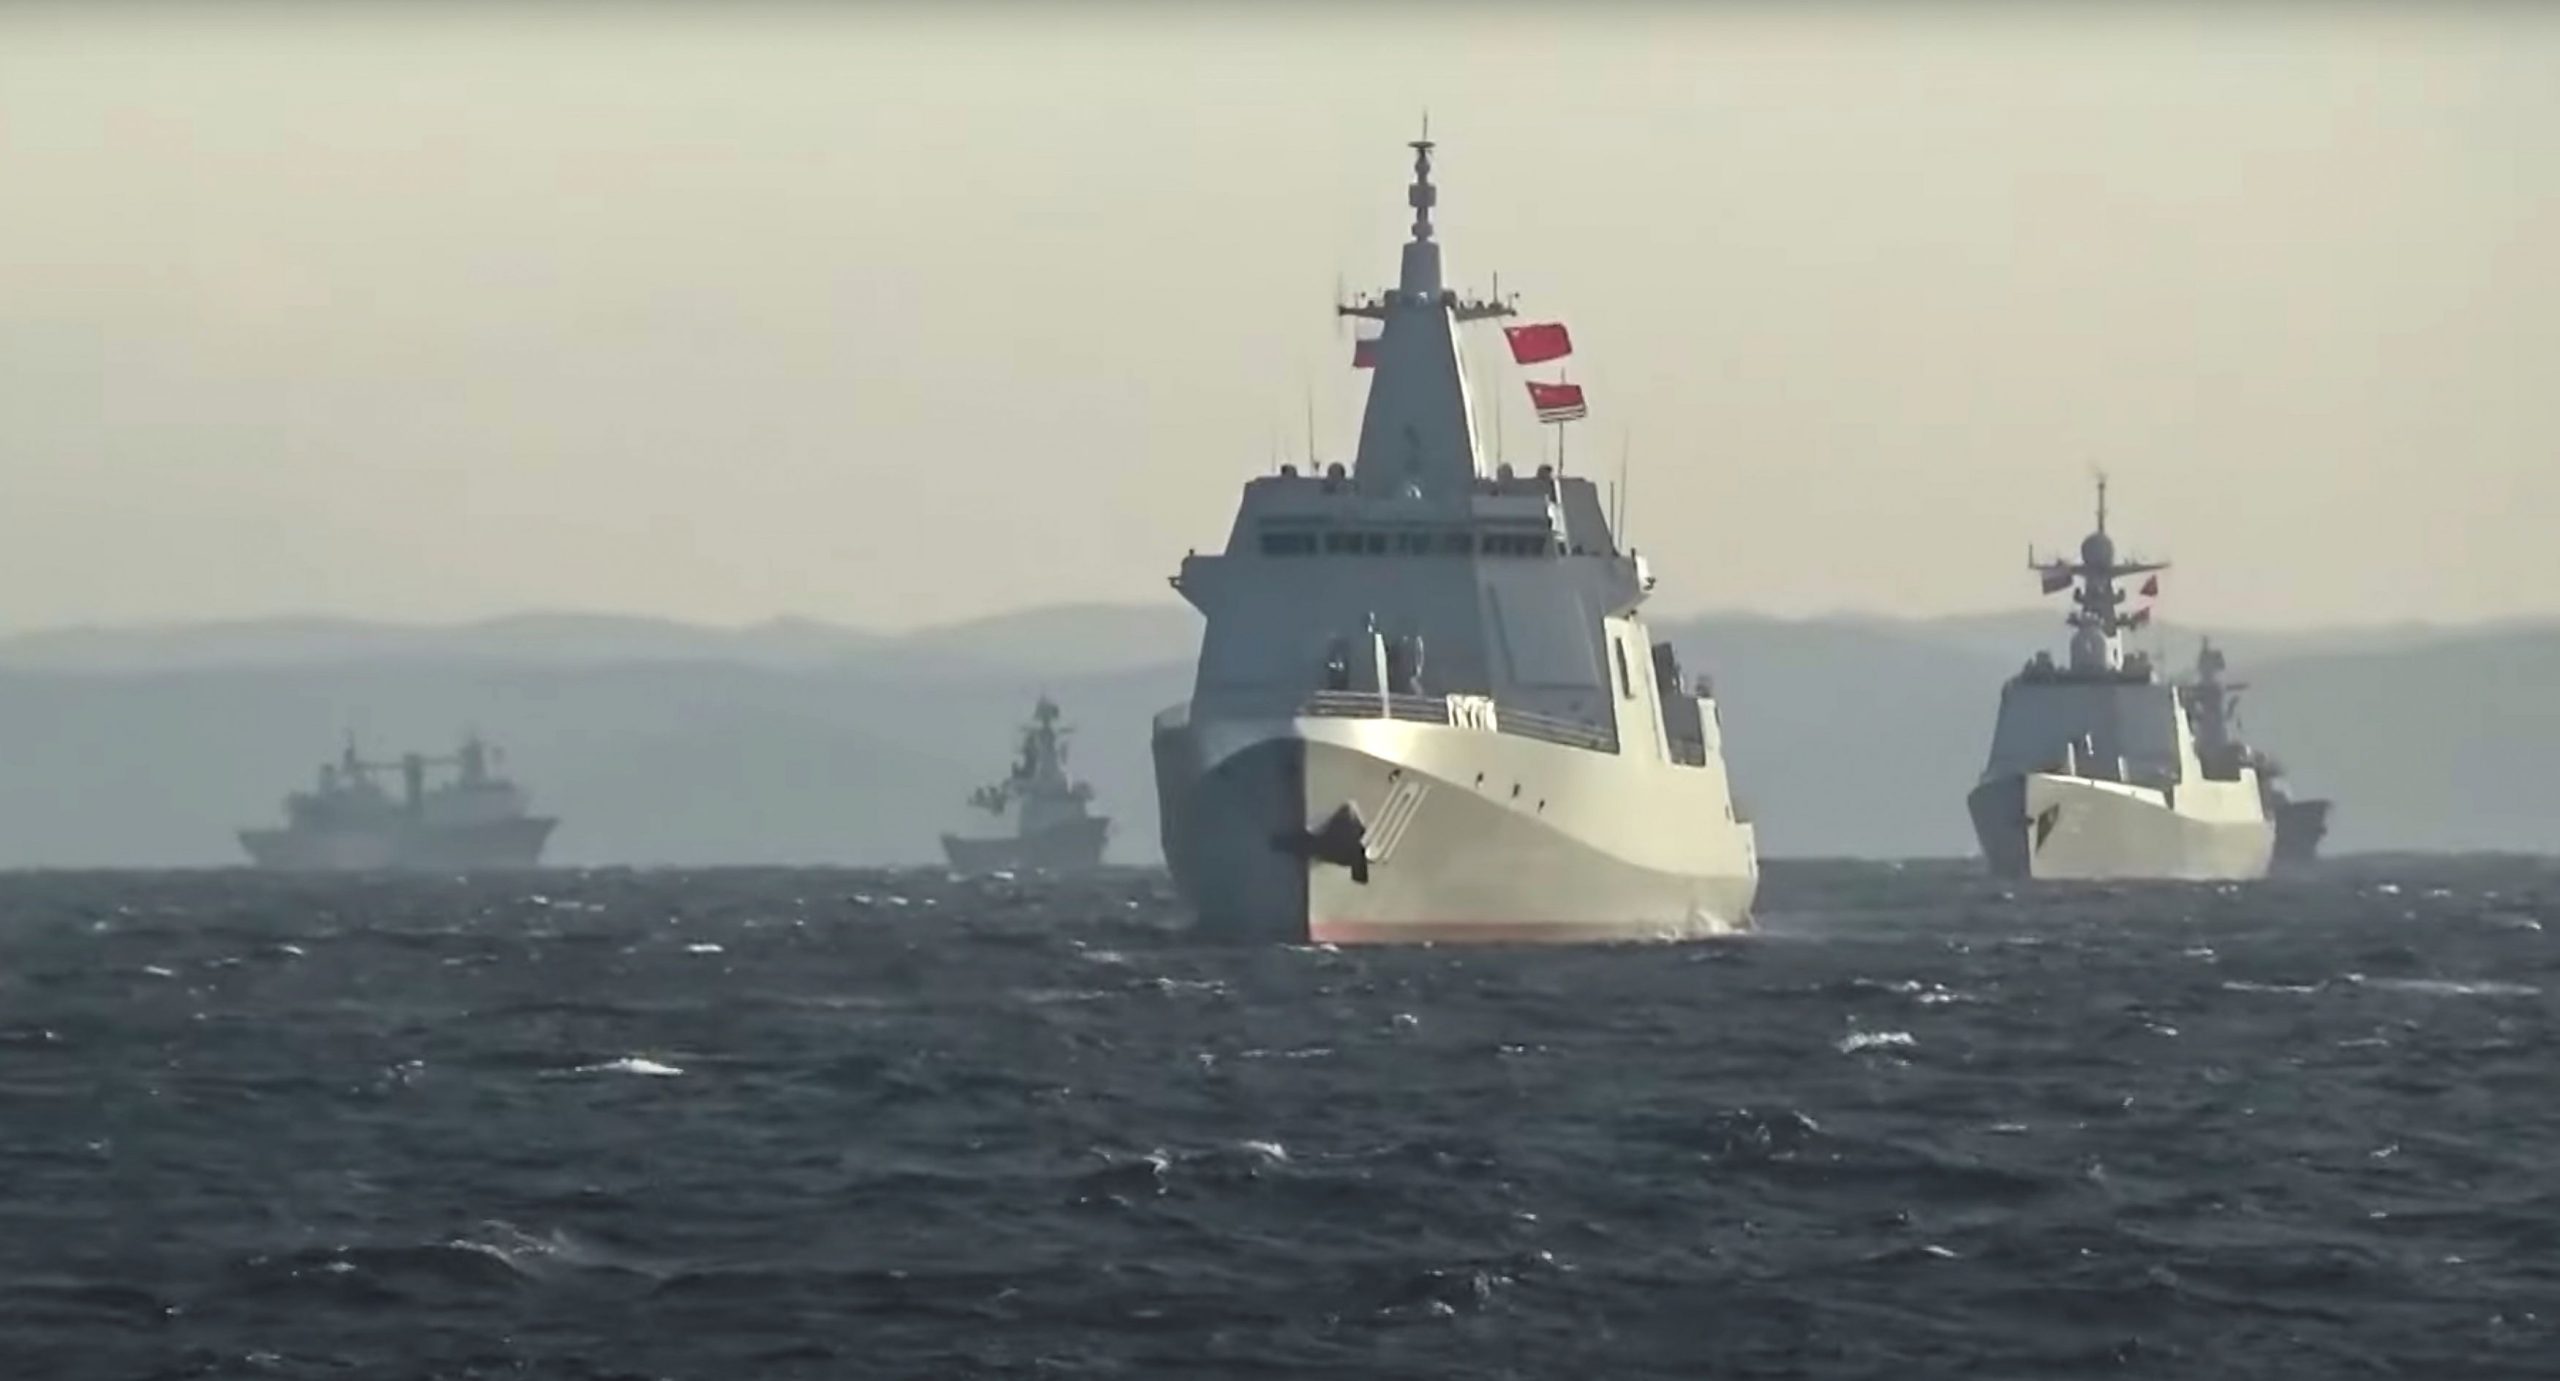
[0,858,2560,1381]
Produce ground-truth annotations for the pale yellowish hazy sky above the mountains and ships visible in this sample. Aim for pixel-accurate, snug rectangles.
[0,5,2560,628]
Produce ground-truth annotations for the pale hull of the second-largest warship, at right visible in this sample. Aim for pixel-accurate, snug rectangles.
[1966,771,2276,881]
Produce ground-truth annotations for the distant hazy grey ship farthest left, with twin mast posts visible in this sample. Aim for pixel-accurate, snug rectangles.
[241,735,558,871]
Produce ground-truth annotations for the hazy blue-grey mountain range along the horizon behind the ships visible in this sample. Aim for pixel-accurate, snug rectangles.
[0,605,2560,866]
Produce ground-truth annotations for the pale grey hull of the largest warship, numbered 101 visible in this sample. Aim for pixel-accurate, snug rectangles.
[1155,717,1759,945]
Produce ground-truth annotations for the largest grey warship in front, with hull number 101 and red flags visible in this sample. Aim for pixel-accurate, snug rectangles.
[1152,136,1759,943]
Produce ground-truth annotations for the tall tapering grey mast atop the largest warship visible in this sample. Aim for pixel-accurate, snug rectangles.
[1334,123,1513,500]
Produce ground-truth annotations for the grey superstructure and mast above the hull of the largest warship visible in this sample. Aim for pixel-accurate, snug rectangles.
[1172,138,1713,761]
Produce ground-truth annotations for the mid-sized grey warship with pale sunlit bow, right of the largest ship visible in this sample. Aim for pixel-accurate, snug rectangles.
[1966,479,2276,879]
